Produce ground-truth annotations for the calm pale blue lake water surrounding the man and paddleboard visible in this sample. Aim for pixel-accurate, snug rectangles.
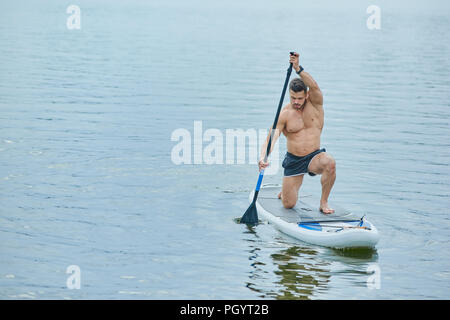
[0,0,450,299]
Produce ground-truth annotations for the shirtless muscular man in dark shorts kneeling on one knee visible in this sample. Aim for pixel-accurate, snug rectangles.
[258,53,336,214]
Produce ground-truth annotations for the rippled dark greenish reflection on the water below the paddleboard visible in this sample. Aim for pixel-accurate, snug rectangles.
[244,226,378,300]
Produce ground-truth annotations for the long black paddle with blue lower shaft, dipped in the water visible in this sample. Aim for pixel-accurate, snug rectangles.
[240,52,294,225]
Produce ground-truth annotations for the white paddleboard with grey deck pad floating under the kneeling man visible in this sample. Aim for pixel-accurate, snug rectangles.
[249,186,380,248]
